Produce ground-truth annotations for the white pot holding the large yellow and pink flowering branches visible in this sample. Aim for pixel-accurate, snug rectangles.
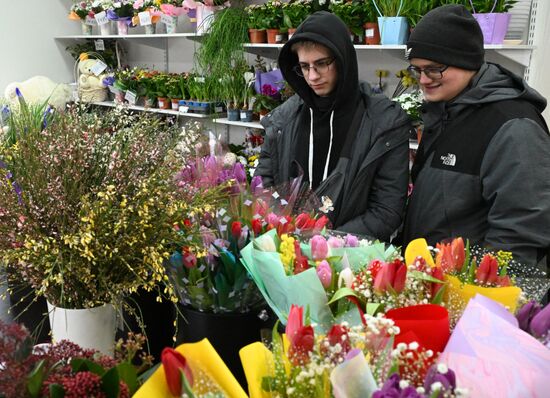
[48,302,116,355]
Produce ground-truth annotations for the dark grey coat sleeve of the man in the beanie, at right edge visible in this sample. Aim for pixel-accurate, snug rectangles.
[481,119,550,265]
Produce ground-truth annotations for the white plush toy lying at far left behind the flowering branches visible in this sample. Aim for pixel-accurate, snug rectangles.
[4,76,72,110]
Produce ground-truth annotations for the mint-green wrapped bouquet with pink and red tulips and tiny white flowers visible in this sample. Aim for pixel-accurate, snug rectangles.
[241,232,443,331]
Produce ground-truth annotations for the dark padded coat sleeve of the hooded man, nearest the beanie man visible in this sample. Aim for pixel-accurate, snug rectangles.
[338,125,410,242]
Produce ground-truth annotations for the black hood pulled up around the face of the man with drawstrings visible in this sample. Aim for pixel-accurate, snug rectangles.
[279,11,359,109]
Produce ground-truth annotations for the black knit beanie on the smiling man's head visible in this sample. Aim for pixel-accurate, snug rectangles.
[407,4,485,70]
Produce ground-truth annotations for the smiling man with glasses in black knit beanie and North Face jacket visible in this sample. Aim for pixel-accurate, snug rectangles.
[403,5,550,274]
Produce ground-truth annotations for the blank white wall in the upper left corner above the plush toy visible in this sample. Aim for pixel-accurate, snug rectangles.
[0,0,80,96]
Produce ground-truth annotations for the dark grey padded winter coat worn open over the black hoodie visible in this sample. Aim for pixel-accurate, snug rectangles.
[256,83,410,241]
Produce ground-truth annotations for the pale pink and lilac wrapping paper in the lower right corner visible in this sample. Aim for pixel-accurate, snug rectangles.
[439,295,550,398]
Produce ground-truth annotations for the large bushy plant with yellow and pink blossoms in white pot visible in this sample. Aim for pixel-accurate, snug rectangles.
[0,101,185,352]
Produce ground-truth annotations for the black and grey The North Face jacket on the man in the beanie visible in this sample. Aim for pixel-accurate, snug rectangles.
[404,64,550,264]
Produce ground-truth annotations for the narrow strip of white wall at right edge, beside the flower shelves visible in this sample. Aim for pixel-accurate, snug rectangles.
[529,0,550,124]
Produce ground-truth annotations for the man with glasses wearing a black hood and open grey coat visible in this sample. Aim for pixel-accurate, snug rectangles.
[256,11,411,241]
